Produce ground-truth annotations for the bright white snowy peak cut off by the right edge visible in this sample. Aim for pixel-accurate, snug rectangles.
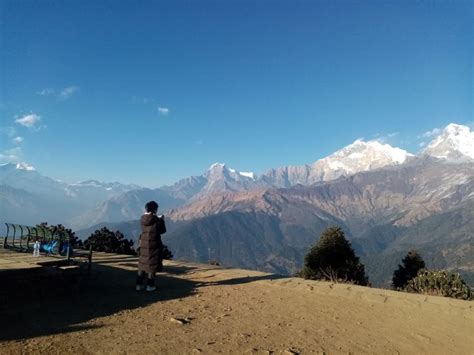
[422,123,474,161]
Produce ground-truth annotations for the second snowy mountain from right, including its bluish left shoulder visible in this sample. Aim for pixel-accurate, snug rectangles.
[261,139,413,187]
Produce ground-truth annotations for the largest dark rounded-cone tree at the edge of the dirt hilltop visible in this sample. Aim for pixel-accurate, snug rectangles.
[302,227,368,286]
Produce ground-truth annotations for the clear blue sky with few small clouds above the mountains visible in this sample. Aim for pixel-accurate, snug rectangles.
[0,0,474,187]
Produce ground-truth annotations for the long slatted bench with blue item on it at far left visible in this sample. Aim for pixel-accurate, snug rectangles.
[2,223,92,271]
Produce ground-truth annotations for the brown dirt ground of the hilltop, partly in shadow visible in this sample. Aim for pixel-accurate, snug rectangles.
[0,254,474,354]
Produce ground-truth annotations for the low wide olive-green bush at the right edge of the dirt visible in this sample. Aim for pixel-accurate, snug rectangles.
[406,269,474,300]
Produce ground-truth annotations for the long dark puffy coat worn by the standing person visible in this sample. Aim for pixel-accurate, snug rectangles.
[138,214,166,273]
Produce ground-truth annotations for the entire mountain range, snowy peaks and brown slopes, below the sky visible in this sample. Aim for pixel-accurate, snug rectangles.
[0,124,474,284]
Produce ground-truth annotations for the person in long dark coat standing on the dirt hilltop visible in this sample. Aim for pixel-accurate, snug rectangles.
[136,201,166,291]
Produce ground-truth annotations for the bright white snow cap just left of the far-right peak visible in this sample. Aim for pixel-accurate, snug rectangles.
[313,139,413,174]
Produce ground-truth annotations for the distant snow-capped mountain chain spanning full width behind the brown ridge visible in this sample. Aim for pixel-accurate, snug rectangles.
[0,124,474,231]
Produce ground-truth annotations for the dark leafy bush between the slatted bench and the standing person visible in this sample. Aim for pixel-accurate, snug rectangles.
[84,227,136,255]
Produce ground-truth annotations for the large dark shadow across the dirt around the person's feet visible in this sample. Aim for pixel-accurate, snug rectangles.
[0,262,278,342]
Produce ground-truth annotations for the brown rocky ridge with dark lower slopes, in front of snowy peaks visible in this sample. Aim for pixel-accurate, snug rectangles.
[78,156,474,286]
